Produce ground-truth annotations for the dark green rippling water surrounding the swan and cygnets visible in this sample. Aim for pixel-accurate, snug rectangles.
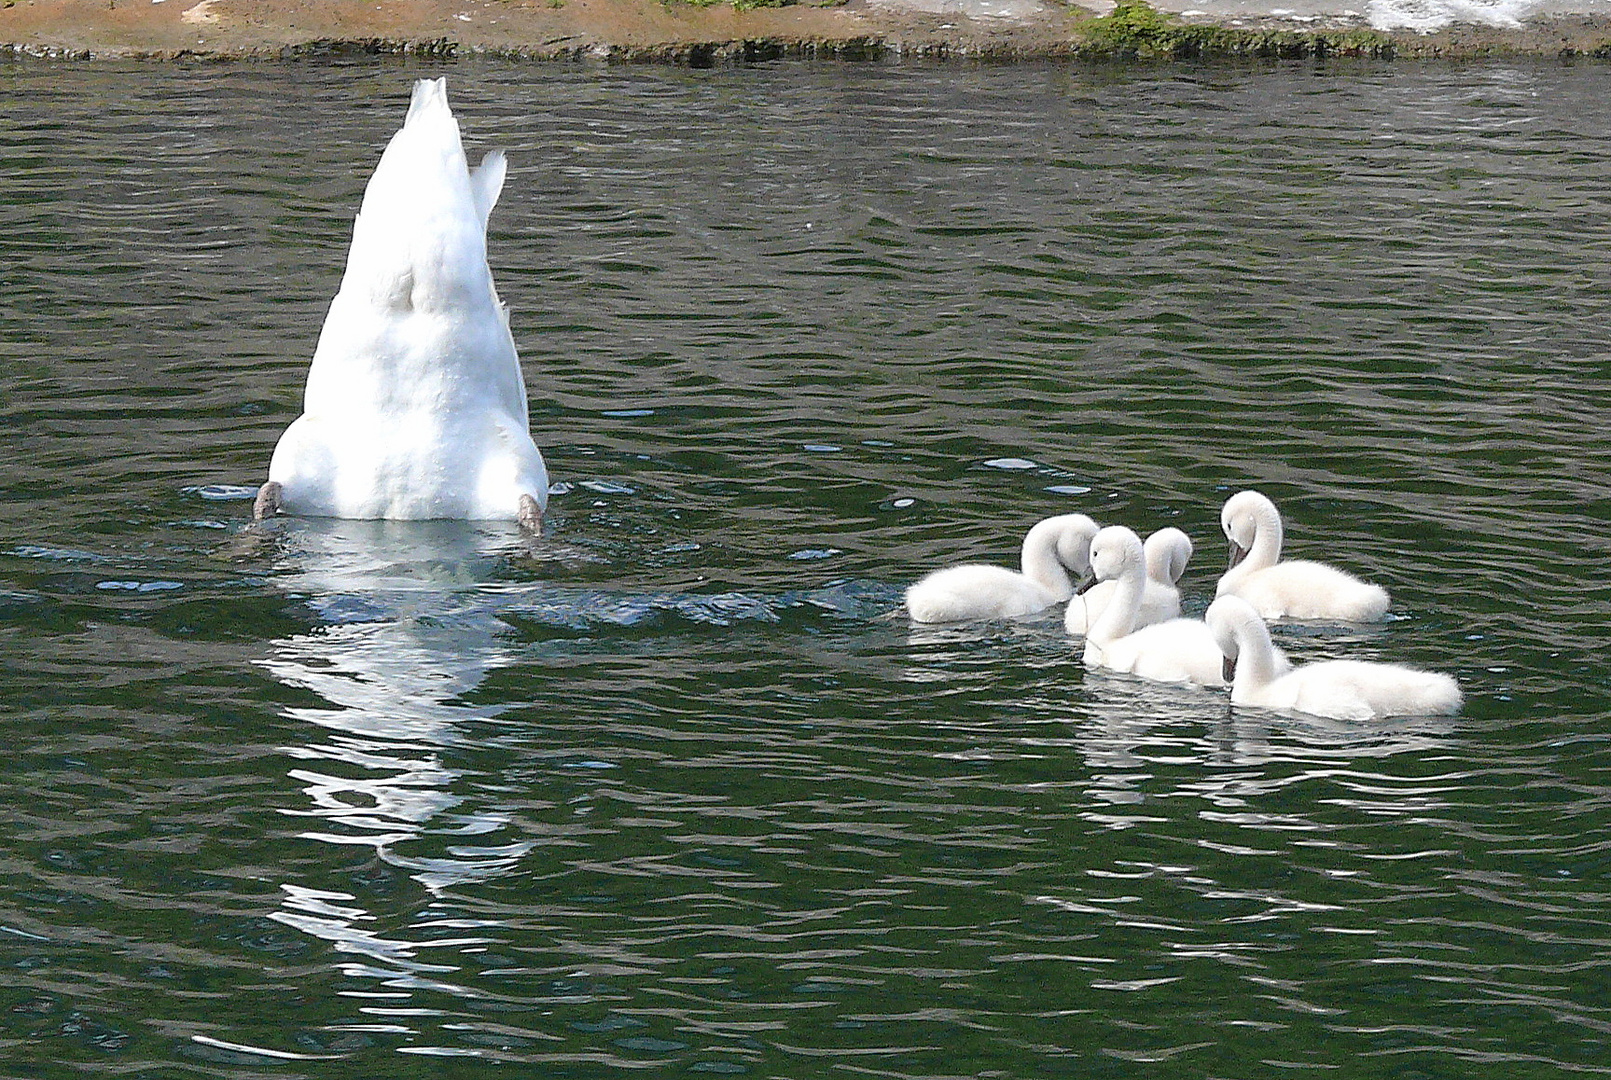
[0,63,1611,1080]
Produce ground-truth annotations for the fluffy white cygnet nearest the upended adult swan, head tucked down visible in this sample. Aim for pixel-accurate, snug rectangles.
[905,514,1097,622]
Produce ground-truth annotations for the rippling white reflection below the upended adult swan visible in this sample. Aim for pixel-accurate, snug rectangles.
[263,519,533,985]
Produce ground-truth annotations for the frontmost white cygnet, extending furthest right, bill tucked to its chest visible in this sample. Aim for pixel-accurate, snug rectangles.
[1205,596,1461,721]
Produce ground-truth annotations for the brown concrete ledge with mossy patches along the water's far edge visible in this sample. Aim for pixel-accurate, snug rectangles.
[0,0,1611,66]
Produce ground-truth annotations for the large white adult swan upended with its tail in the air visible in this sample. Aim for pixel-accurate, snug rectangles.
[258,79,548,525]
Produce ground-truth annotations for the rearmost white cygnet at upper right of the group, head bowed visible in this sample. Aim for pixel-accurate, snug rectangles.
[1215,492,1389,622]
